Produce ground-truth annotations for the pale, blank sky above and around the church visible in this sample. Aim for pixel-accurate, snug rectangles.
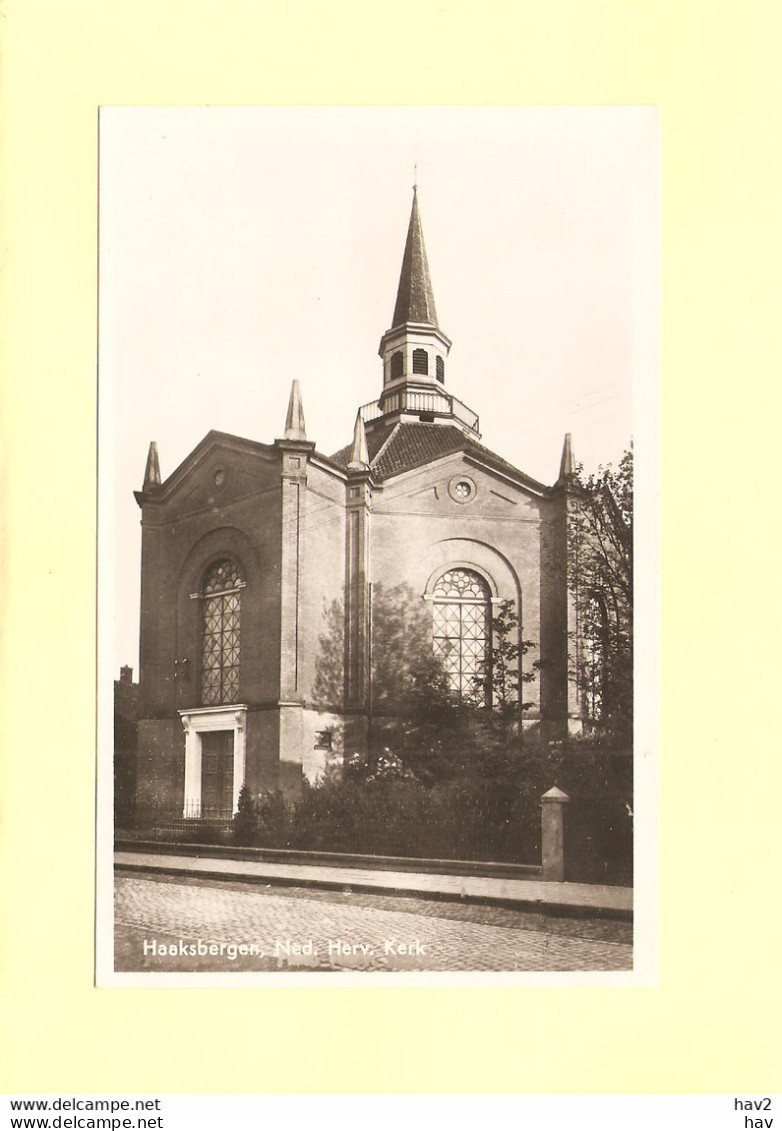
[98,107,659,677]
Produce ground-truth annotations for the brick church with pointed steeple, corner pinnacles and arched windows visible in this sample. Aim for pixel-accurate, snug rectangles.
[136,192,581,817]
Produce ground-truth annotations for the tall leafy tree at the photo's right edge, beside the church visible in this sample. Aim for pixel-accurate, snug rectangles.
[568,447,633,743]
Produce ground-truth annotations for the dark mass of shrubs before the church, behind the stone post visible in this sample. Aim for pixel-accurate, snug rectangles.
[226,742,633,882]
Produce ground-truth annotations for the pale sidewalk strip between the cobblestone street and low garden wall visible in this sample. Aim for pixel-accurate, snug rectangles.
[114,852,633,920]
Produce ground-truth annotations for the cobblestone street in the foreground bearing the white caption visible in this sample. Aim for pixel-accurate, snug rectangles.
[114,874,633,973]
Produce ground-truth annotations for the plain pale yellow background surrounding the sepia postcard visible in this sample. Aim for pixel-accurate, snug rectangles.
[0,0,782,1094]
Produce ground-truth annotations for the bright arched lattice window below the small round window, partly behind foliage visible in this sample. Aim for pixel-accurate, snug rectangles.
[432,569,491,707]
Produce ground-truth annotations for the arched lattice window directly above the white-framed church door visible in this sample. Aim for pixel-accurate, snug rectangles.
[201,558,244,707]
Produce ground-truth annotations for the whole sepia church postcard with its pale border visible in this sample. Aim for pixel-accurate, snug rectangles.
[97,106,659,985]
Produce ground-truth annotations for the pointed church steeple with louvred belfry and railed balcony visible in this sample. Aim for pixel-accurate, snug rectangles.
[366,187,479,438]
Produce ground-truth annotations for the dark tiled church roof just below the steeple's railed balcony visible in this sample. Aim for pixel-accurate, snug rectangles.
[330,423,545,490]
